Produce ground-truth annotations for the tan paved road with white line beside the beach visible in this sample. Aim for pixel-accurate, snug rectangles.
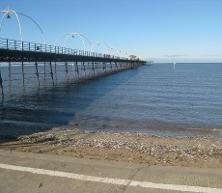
[0,150,222,193]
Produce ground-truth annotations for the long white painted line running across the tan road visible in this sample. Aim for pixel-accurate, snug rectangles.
[0,164,222,193]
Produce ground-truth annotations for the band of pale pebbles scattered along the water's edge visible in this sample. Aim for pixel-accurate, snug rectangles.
[18,129,222,163]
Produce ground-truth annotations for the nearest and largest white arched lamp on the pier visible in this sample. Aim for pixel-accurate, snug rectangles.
[0,8,45,43]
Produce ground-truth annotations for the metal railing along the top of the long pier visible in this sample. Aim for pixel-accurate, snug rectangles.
[0,37,127,60]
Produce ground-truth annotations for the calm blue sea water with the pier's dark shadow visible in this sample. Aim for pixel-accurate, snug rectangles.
[0,64,222,136]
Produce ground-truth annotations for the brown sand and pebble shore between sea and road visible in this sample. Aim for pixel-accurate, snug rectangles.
[0,128,222,168]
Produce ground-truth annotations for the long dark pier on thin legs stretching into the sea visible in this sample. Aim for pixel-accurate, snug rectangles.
[0,38,146,101]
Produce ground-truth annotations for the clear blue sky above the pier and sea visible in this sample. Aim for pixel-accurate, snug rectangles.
[0,0,222,62]
